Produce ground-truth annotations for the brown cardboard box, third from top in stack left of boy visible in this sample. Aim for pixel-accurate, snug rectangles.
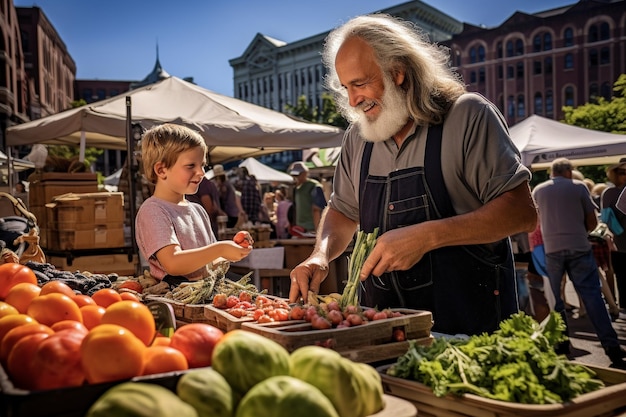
[48,223,125,250]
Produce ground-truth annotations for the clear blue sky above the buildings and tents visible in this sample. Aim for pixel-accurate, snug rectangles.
[14,0,576,96]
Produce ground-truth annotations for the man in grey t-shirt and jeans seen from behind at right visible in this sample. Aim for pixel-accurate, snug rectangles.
[532,158,626,369]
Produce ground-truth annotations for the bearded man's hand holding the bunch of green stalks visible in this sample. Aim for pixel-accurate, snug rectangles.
[359,225,432,281]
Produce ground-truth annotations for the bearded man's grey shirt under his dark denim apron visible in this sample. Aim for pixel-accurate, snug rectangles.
[329,93,531,221]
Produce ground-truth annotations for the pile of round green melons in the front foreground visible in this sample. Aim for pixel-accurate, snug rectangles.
[86,330,385,417]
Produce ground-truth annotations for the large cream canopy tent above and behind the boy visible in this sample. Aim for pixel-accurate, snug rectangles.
[6,77,343,163]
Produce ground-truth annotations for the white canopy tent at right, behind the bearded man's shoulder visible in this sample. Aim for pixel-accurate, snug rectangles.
[510,115,626,168]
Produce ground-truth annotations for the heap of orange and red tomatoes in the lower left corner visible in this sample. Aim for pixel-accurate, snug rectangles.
[0,264,219,390]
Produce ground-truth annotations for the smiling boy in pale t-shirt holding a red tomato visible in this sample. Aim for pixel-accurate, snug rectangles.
[135,123,253,286]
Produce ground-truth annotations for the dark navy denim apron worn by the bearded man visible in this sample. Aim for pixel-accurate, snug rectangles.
[359,125,518,335]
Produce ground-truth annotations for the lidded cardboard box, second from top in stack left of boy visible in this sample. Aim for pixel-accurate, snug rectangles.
[46,192,124,230]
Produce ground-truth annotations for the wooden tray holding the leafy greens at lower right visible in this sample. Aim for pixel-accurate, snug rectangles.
[377,365,626,417]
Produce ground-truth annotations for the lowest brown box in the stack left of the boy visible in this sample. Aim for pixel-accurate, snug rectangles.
[48,253,138,276]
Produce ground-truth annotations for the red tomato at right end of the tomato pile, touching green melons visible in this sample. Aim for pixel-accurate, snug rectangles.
[170,323,224,368]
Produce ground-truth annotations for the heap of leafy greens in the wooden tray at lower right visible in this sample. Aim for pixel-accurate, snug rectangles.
[387,312,604,404]
